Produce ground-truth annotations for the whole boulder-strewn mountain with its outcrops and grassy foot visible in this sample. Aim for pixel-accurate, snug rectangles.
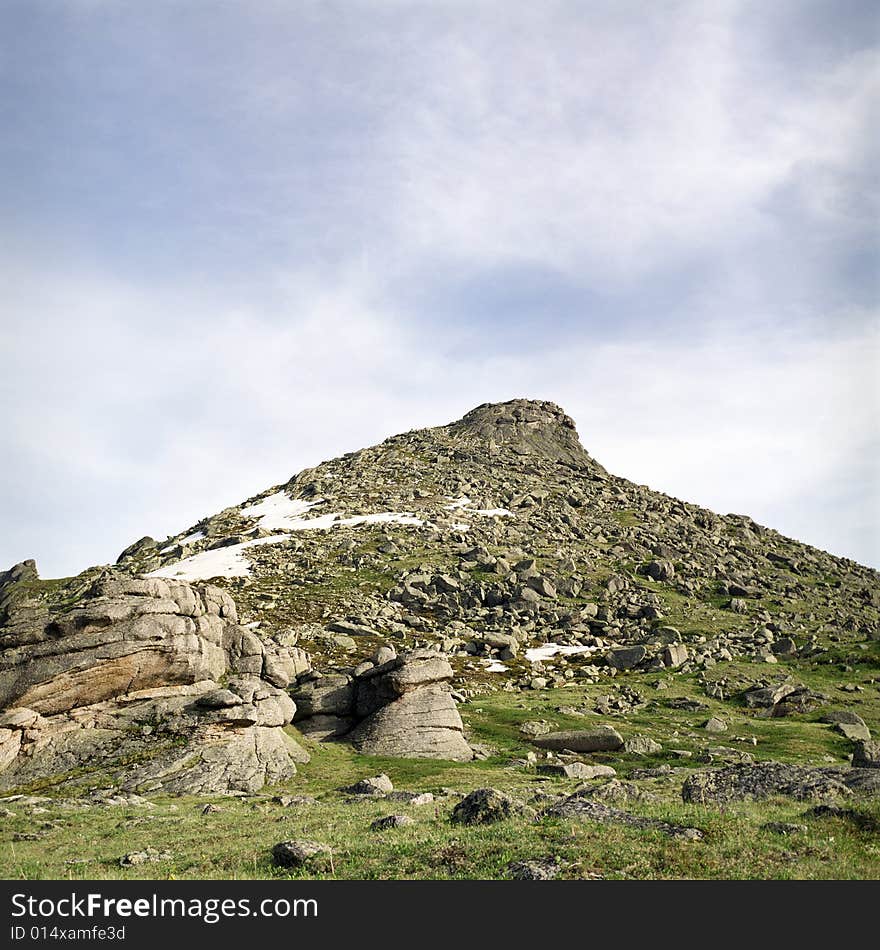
[0,400,880,877]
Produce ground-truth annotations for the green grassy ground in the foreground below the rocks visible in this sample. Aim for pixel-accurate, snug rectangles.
[0,664,880,879]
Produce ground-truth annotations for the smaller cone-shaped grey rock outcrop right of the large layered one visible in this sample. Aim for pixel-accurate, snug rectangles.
[293,650,473,761]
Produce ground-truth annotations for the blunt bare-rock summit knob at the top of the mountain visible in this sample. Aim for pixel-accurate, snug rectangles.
[446,399,596,468]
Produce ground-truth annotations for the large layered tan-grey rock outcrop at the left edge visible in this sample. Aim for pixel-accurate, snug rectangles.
[0,562,308,794]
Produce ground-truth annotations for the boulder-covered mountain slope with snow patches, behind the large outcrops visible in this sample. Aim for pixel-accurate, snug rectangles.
[108,399,880,696]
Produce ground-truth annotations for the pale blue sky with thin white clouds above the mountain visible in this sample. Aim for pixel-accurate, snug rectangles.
[0,0,880,577]
